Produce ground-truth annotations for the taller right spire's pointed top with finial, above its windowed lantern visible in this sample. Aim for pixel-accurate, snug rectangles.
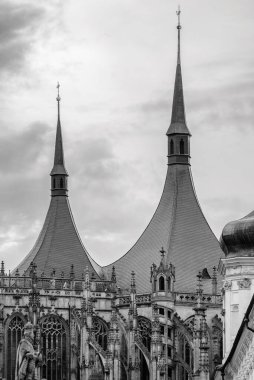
[167,7,190,135]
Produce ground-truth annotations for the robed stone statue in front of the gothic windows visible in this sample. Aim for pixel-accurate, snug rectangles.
[15,322,41,380]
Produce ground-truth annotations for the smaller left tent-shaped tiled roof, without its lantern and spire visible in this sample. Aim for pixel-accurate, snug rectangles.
[15,196,99,279]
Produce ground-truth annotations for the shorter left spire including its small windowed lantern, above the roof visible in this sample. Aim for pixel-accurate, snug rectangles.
[50,82,68,196]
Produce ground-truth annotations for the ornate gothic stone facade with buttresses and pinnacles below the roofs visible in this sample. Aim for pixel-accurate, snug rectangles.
[0,263,222,380]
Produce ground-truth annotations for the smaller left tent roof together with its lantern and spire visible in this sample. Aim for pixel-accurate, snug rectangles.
[14,88,100,279]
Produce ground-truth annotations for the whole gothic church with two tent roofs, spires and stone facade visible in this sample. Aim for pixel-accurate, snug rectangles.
[0,11,227,380]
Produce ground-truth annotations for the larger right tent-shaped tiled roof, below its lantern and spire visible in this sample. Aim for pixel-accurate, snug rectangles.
[104,165,222,292]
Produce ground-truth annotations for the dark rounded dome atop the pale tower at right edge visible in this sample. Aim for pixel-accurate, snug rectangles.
[220,211,254,256]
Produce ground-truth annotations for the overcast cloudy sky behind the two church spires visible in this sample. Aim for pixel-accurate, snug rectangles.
[0,0,254,269]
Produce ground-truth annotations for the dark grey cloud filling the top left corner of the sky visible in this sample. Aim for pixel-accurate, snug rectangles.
[0,0,63,79]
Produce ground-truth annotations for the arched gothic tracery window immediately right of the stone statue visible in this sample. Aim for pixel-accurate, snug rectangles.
[40,315,69,380]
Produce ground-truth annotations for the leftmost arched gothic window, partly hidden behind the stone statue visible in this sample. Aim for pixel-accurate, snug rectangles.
[5,314,25,380]
